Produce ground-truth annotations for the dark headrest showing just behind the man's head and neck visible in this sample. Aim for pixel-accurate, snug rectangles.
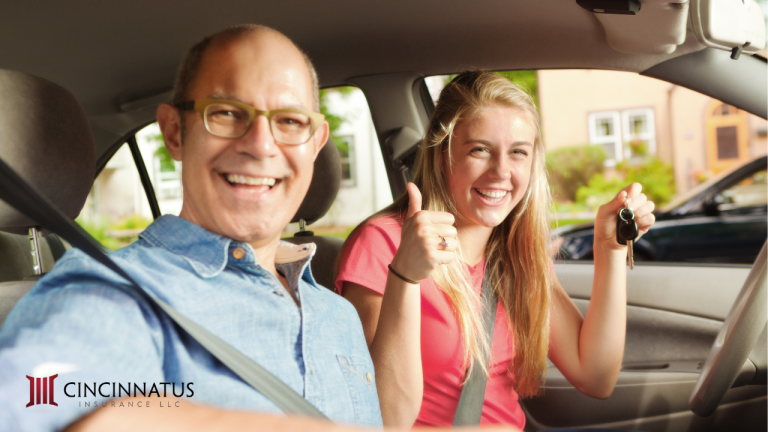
[291,136,341,224]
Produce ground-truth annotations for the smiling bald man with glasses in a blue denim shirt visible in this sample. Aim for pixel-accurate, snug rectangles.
[0,26,381,431]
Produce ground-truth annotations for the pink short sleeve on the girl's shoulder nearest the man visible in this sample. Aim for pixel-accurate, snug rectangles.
[336,218,400,295]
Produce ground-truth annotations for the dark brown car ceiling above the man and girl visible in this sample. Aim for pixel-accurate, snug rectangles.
[0,0,702,159]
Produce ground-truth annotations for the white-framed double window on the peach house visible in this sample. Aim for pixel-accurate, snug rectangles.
[588,108,656,166]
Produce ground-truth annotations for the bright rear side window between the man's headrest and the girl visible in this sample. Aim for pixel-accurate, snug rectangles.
[283,87,392,238]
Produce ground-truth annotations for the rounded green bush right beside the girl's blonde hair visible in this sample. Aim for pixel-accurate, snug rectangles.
[546,145,605,201]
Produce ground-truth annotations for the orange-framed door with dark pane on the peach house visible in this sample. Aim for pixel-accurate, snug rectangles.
[705,101,749,174]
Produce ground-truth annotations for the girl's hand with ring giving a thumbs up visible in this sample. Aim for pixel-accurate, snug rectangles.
[391,183,458,281]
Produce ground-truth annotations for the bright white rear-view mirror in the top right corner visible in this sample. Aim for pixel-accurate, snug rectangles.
[691,0,765,58]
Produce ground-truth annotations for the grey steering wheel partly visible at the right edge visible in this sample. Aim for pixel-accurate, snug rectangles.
[688,243,768,417]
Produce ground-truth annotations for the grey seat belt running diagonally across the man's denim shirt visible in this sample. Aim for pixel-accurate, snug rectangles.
[0,158,327,419]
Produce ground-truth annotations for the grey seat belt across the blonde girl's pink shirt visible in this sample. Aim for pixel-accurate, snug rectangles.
[453,268,499,427]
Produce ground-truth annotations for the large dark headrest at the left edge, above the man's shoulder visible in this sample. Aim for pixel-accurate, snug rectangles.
[0,69,96,234]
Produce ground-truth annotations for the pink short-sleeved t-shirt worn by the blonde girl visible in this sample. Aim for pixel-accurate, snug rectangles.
[336,217,525,429]
